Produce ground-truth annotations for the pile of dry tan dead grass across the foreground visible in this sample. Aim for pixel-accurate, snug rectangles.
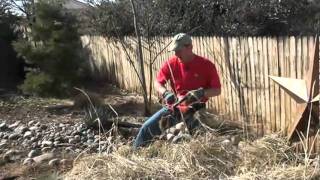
[65,133,320,180]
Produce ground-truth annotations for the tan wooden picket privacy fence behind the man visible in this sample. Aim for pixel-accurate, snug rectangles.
[82,36,314,138]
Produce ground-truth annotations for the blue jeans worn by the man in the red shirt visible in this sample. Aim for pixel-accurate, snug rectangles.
[133,107,199,148]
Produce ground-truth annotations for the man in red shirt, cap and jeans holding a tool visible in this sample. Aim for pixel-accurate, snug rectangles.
[133,33,221,148]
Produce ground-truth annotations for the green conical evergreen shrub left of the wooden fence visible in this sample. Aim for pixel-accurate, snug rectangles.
[14,0,87,96]
